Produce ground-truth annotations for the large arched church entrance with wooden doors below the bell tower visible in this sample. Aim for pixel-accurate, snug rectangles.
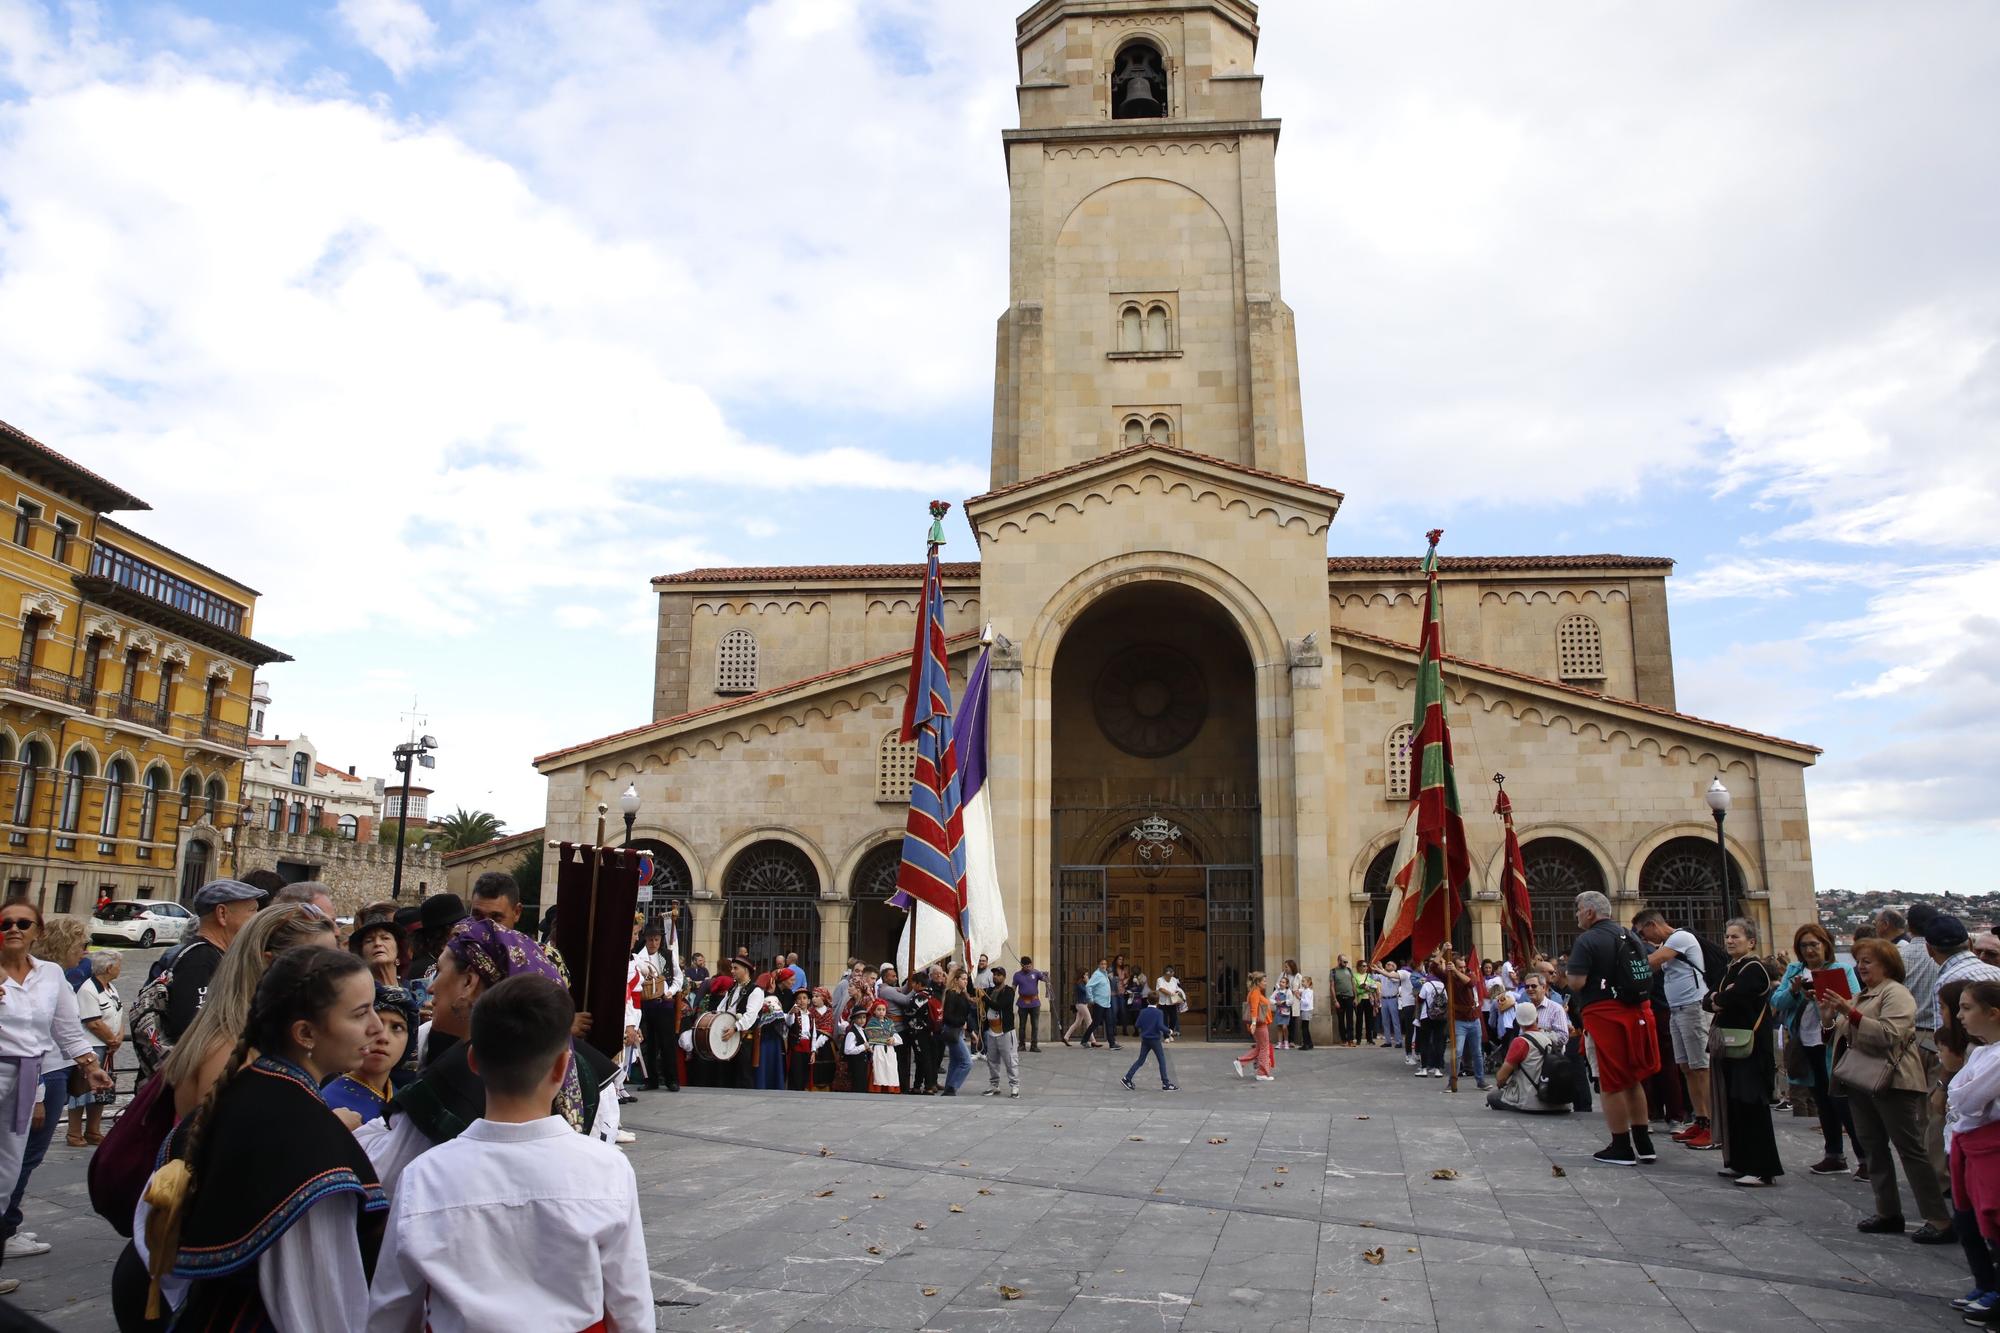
[1050,582,1260,1037]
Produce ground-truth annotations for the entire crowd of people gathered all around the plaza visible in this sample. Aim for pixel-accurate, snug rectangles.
[0,875,2000,1333]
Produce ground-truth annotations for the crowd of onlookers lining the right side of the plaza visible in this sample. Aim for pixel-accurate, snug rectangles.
[1344,893,2000,1327]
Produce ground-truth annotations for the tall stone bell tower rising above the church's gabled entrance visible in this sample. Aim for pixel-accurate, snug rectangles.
[992,0,1306,486]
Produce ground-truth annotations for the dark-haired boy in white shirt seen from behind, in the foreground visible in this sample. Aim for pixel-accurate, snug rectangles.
[368,977,654,1333]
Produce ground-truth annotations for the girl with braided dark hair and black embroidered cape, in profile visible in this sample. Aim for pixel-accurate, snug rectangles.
[134,947,388,1333]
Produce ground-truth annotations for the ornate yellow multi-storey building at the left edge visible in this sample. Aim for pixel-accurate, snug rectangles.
[0,422,290,913]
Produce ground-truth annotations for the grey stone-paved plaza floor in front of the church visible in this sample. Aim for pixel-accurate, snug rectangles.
[6,1043,1968,1333]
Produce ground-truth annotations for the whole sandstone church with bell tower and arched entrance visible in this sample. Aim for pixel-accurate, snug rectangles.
[534,0,1818,1031]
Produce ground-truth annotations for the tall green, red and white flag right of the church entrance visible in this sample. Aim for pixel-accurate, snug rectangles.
[1374,528,1472,959]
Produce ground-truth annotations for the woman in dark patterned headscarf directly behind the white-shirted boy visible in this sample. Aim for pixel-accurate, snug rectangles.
[354,919,618,1193]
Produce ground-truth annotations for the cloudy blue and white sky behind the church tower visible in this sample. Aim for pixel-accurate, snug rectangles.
[0,0,2000,891]
